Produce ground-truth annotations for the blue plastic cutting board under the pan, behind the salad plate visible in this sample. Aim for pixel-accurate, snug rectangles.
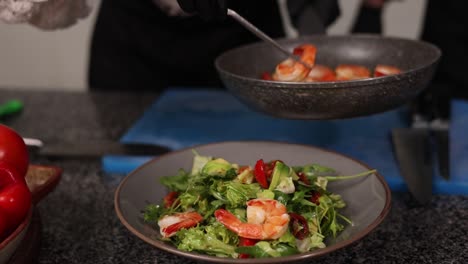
[102,88,468,194]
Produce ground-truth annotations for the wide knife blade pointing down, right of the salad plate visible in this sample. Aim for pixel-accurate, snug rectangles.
[391,128,433,204]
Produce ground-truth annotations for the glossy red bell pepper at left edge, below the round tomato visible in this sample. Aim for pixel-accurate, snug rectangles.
[0,162,31,241]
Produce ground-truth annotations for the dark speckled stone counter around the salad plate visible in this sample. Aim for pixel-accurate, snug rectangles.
[0,89,468,264]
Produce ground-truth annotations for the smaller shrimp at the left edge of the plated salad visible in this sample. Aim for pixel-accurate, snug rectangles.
[158,212,203,238]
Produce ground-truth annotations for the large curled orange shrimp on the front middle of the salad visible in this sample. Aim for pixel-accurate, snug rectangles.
[215,199,289,240]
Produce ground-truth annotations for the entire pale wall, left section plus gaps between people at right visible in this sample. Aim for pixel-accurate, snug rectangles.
[0,0,425,90]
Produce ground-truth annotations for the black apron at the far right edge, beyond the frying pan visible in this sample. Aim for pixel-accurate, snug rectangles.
[418,0,468,118]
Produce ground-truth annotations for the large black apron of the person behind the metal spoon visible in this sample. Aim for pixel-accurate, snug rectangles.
[88,0,284,91]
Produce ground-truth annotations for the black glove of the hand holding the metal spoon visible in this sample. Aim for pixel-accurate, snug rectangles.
[177,0,227,20]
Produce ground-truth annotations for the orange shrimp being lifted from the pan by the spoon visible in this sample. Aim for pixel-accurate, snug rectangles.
[272,44,317,82]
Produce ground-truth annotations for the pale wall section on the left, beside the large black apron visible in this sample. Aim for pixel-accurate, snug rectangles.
[0,1,99,90]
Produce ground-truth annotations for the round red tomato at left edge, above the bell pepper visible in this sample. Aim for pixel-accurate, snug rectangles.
[0,124,29,177]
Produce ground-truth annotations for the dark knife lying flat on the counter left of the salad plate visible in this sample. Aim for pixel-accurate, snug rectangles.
[24,138,171,158]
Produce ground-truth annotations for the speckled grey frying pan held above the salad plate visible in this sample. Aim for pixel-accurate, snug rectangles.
[215,35,441,120]
